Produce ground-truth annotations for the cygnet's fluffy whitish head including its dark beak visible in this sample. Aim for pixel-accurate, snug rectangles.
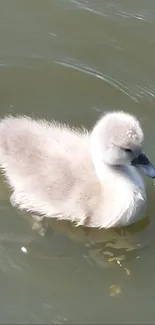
[91,111,155,177]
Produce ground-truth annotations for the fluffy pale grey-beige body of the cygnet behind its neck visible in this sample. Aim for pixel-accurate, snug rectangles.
[0,116,101,223]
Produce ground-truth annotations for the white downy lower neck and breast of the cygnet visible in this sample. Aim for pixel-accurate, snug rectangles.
[93,149,146,228]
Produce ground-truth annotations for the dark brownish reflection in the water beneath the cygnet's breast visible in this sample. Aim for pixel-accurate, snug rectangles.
[47,213,151,267]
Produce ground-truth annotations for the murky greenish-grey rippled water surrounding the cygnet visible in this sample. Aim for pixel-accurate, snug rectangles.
[0,0,155,324]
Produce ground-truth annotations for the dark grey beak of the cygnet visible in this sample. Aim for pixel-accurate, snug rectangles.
[131,153,155,178]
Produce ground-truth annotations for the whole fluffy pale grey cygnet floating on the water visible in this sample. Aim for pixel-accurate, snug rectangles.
[0,111,155,228]
